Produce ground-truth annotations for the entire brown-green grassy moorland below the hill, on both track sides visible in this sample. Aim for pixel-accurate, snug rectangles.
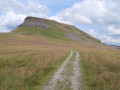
[0,34,120,90]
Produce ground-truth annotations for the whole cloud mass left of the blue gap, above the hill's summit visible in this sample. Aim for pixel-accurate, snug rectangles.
[0,0,49,32]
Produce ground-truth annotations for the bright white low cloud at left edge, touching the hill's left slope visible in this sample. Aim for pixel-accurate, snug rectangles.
[0,11,26,32]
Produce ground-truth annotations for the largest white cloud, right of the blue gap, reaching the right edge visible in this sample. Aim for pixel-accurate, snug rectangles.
[52,0,120,25]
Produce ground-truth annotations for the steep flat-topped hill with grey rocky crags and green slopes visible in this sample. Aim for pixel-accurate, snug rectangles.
[11,17,100,43]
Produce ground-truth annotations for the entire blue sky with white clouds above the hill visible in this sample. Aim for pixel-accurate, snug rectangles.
[0,0,120,46]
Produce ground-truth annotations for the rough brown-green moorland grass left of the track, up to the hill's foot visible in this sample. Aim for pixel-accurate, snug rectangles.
[0,34,69,90]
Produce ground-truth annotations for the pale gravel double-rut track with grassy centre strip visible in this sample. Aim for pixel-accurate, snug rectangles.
[43,50,81,90]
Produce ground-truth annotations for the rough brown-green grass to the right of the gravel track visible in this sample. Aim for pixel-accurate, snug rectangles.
[80,49,120,90]
